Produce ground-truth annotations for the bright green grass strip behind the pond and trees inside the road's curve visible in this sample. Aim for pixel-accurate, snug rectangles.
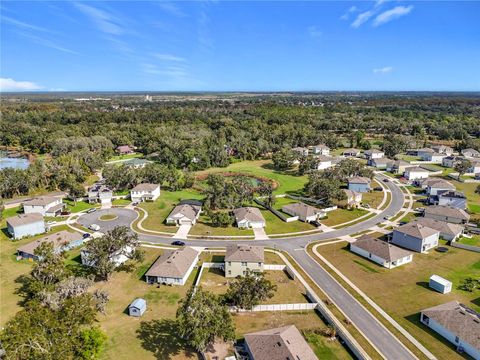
[197,160,307,194]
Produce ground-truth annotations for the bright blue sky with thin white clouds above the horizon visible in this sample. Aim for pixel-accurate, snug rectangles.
[0,0,480,91]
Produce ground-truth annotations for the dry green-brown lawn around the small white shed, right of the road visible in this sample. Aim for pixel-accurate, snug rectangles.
[318,242,480,359]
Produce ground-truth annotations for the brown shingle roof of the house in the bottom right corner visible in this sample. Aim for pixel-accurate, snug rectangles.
[422,301,480,349]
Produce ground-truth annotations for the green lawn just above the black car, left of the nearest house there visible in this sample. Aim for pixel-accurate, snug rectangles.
[138,190,203,233]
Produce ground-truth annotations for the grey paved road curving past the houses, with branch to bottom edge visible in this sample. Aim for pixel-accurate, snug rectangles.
[80,175,415,360]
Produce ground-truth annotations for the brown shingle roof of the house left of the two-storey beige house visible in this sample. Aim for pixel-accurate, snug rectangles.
[145,246,198,278]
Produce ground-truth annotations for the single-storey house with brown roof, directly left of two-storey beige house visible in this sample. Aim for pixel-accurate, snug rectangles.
[145,246,200,285]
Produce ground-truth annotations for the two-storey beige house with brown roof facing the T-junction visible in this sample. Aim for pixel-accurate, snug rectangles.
[225,244,265,277]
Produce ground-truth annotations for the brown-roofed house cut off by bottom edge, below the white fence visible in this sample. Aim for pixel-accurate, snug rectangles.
[245,325,318,360]
